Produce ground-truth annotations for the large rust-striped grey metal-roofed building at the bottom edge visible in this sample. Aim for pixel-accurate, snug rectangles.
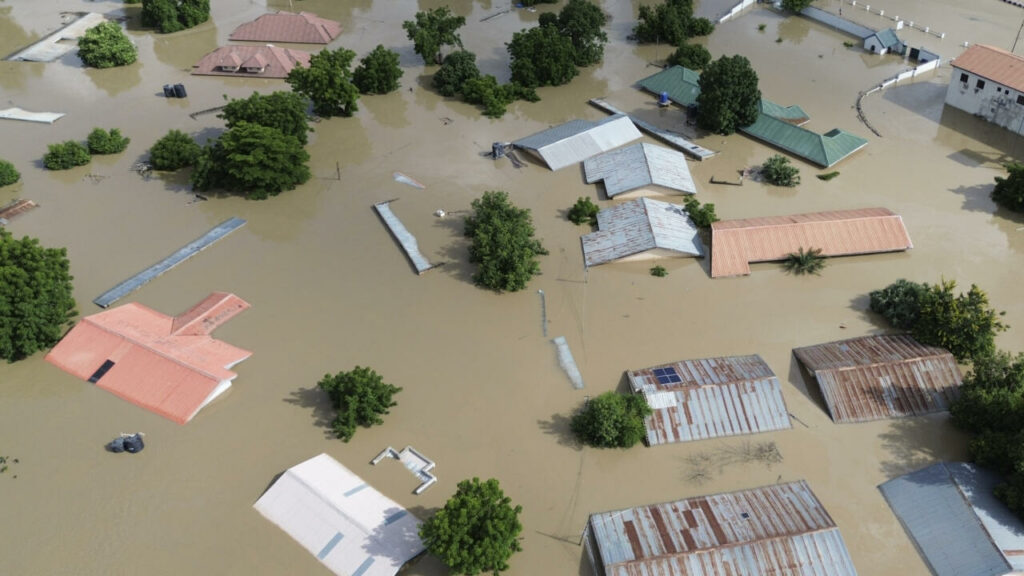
[585,481,857,576]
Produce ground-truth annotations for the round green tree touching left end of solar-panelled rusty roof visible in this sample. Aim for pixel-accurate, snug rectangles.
[569,392,651,448]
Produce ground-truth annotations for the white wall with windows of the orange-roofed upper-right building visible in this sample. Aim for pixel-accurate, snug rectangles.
[946,66,1024,134]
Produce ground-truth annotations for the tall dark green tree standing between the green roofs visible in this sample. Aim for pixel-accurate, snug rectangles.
[697,54,761,134]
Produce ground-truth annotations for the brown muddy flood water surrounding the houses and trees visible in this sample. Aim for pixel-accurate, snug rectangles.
[0,0,1024,576]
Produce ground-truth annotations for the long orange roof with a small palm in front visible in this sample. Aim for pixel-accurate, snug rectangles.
[711,208,913,278]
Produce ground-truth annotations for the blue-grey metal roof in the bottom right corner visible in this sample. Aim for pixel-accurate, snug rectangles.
[879,462,1024,576]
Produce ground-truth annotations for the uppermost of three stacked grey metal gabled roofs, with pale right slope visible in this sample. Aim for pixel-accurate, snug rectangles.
[512,114,641,170]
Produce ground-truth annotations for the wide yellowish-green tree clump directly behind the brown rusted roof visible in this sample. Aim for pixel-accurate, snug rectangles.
[870,280,1008,362]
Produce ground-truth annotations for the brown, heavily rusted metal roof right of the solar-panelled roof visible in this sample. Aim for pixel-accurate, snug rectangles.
[793,334,963,422]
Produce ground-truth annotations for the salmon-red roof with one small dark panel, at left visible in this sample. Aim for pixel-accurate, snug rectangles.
[46,292,252,424]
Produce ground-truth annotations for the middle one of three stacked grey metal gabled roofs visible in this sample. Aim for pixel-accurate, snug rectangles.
[583,142,697,198]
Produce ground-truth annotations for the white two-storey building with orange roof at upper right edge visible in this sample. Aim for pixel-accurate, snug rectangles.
[946,44,1024,134]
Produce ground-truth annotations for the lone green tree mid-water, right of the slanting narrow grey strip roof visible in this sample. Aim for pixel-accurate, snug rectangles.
[465,191,548,292]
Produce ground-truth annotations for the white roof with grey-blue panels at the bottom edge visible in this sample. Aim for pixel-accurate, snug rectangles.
[253,454,425,576]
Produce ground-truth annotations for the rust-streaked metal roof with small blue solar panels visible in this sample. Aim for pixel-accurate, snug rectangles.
[627,356,793,446]
